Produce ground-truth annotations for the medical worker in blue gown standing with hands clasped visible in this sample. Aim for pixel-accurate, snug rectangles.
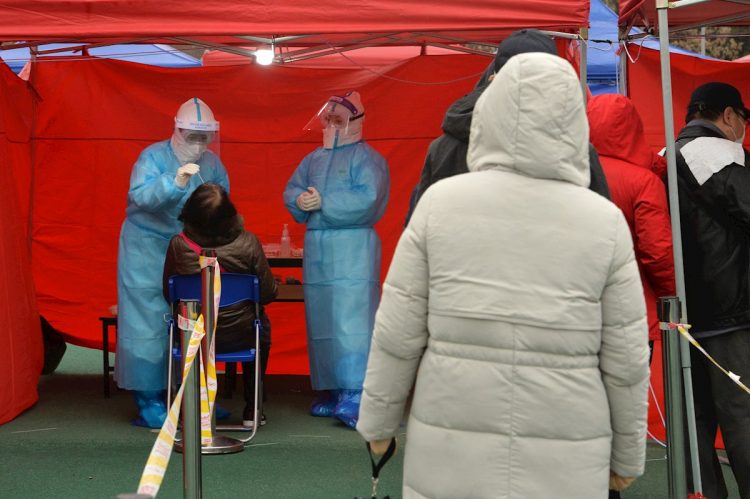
[284,92,390,428]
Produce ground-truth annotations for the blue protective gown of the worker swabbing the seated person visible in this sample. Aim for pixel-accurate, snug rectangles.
[115,140,229,391]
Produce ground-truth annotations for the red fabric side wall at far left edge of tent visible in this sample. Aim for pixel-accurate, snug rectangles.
[0,64,43,424]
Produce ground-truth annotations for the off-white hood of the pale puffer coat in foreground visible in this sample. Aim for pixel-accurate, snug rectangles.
[467,53,590,187]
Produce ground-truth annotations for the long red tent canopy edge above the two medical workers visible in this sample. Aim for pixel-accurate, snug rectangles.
[0,0,589,45]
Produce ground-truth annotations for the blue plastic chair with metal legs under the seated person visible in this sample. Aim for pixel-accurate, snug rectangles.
[167,272,261,438]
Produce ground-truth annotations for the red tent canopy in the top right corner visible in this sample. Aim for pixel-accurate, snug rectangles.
[619,0,750,31]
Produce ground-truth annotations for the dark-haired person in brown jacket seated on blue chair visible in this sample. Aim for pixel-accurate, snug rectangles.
[164,182,278,426]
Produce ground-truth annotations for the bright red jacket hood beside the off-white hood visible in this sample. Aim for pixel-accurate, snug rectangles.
[587,94,664,170]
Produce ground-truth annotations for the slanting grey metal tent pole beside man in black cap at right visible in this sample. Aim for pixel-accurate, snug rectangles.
[656,0,702,499]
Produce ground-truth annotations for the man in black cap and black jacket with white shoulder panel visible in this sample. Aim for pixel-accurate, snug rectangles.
[675,82,750,499]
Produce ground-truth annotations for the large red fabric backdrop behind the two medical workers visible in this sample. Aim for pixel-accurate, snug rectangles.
[30,55,490,374]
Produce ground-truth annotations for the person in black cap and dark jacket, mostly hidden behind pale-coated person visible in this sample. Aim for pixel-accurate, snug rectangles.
[406,29,609,224]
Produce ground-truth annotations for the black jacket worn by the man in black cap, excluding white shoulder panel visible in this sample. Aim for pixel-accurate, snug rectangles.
[676,122,750,337]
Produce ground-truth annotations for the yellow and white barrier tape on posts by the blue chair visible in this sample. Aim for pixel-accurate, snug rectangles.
[138,256,221,497]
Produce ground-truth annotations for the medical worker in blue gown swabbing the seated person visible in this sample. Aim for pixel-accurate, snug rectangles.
[115,98,229,428]
